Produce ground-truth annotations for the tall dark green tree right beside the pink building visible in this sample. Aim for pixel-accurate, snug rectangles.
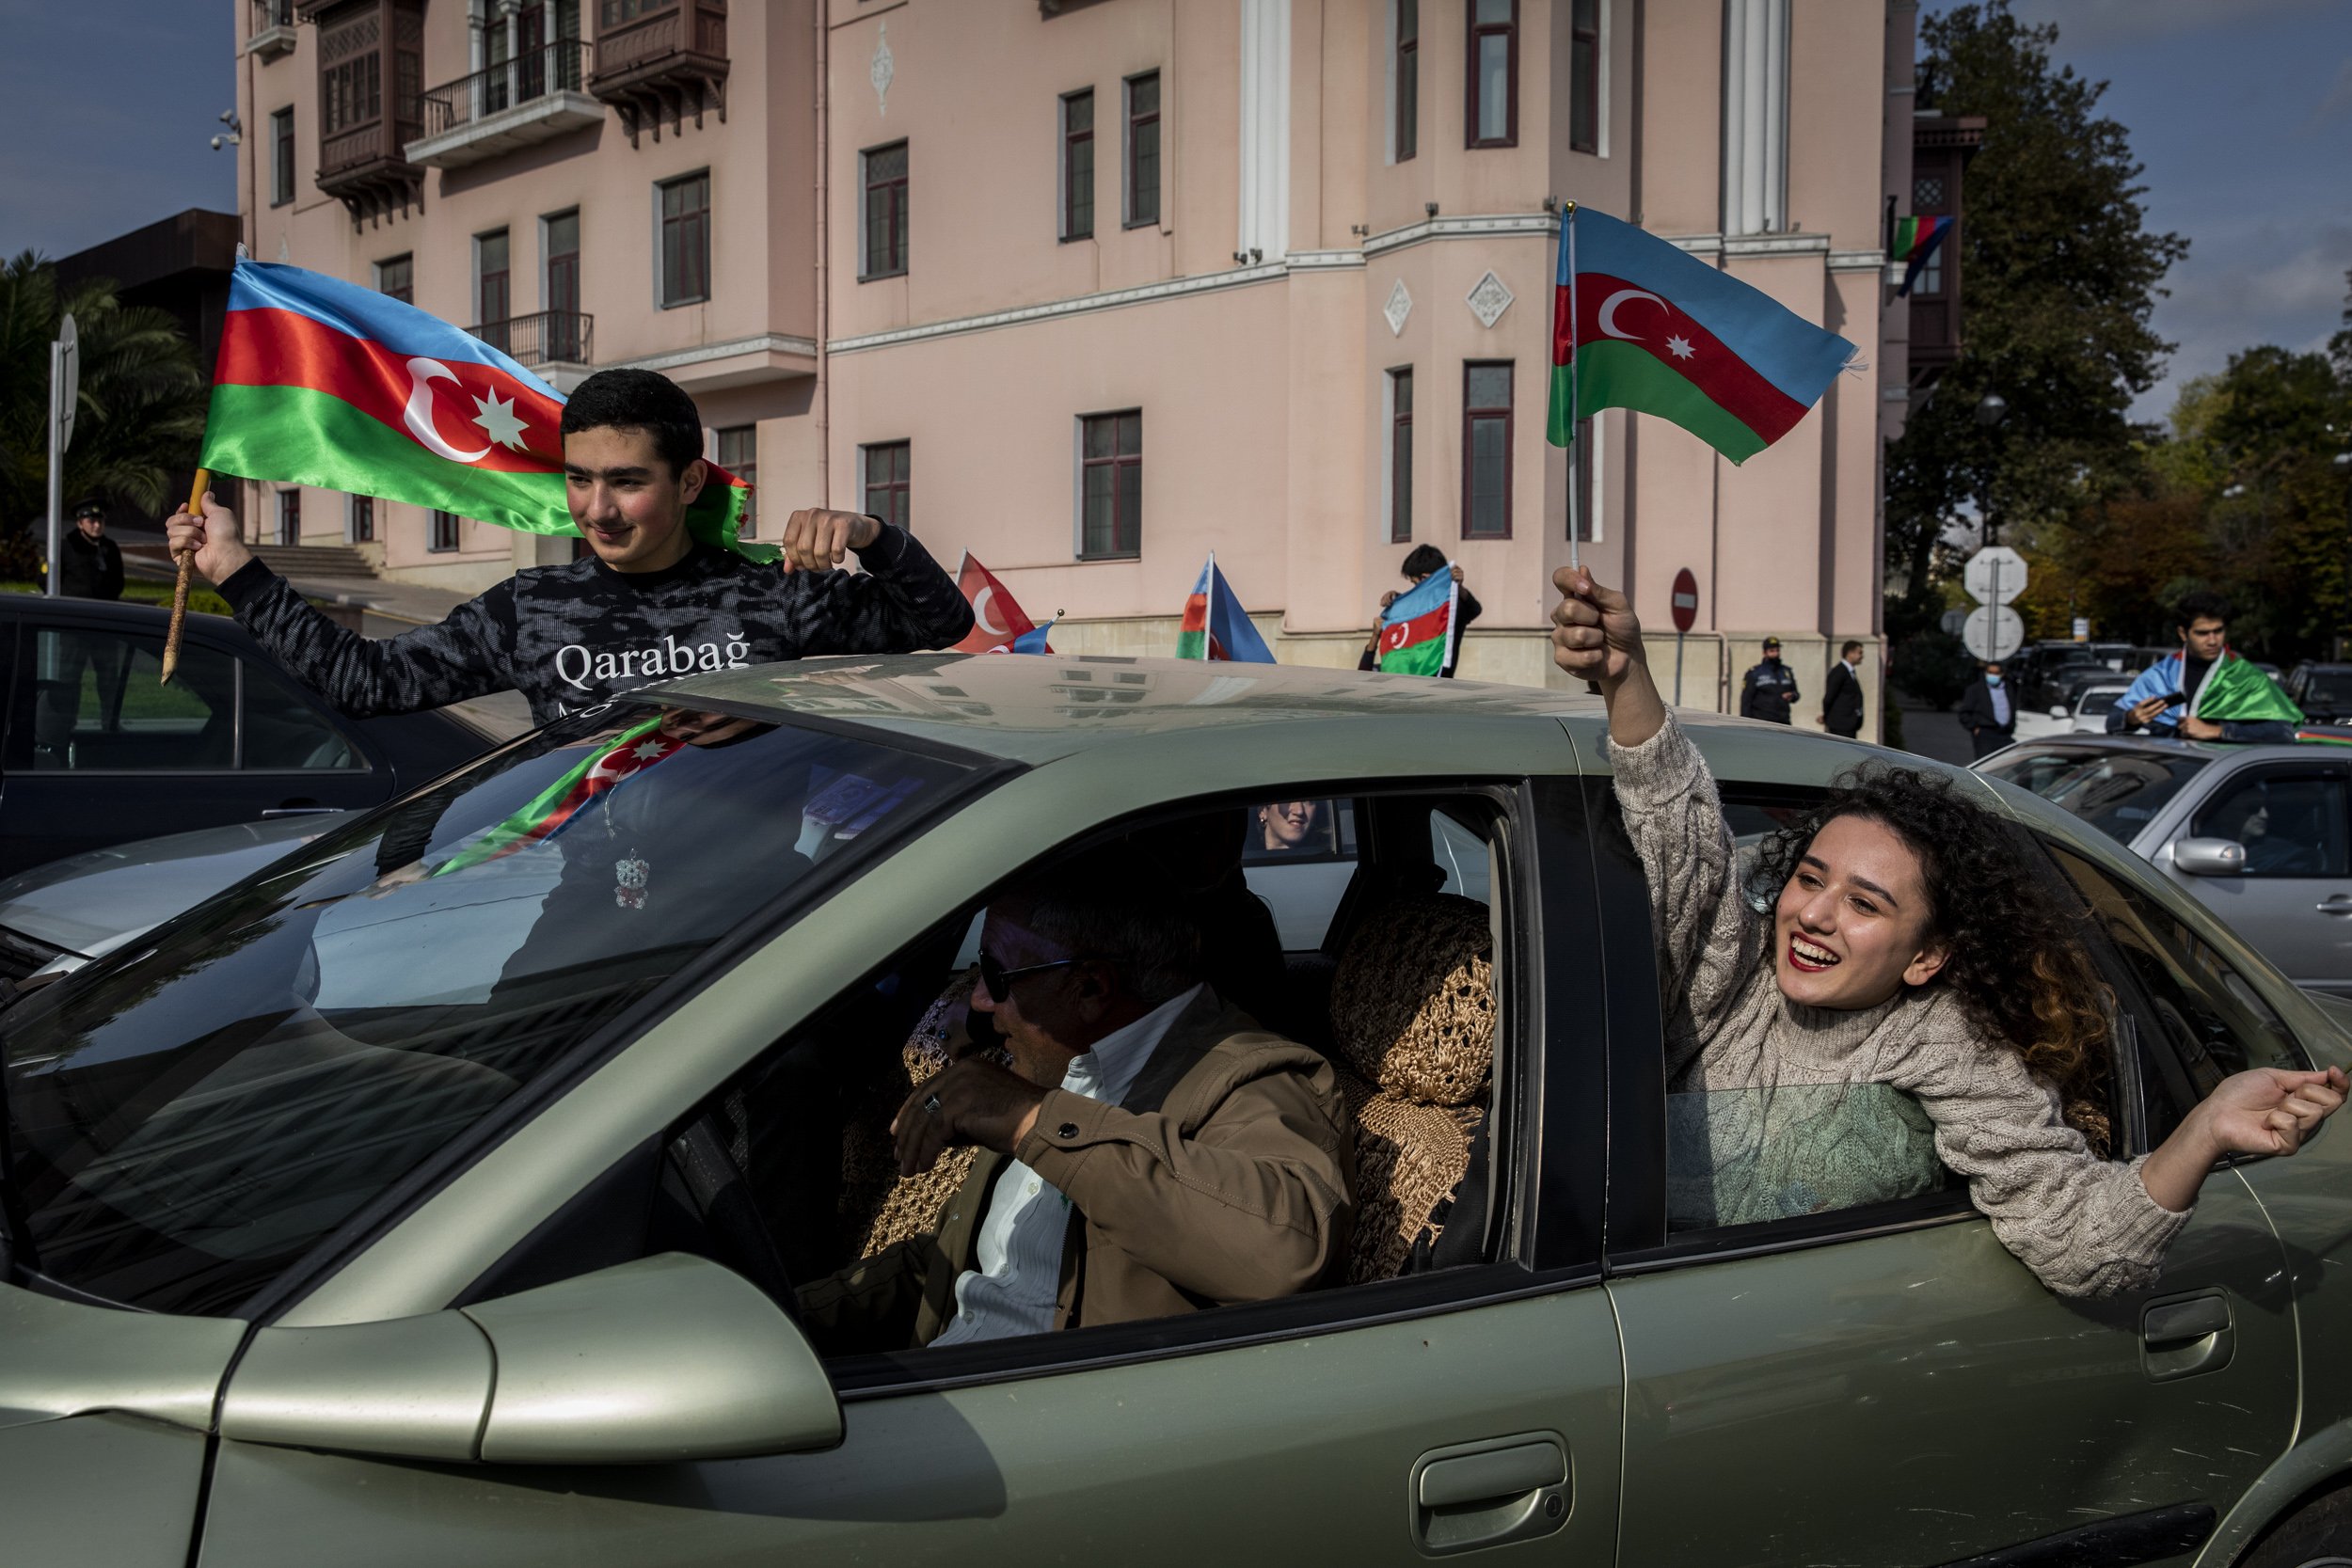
[1886,0,2187,635]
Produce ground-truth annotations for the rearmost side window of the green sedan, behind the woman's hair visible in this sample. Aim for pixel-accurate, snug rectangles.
[2049,844,2310,1143]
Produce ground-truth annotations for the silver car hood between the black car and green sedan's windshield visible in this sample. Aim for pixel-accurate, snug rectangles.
[0,811,358,959]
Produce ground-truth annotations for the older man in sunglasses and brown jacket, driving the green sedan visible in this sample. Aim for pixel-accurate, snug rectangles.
[800,856,1355,1354]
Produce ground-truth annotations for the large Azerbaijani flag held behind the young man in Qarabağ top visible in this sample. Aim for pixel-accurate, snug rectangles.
[200,261,757,560]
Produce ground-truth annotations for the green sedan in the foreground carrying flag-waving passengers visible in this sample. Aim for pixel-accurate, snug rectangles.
[0,656,2352,1568]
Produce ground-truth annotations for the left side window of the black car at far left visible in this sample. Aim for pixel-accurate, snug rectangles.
[9,626,238,773]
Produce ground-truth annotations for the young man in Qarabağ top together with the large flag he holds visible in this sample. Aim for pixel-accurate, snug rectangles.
[167,261,972,724]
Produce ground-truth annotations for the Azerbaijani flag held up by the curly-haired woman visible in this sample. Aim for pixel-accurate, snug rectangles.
[1548,207,1853,463]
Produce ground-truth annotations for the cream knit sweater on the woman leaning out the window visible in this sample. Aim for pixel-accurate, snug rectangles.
[1609,717,2187,1295]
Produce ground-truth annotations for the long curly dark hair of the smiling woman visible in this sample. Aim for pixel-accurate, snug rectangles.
[1753,762,2115,1154]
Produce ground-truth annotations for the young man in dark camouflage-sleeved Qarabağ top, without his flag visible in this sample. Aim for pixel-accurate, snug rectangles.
[167,364,972,724]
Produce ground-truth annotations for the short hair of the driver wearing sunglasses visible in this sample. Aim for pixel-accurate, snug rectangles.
[995,851,1202,1006]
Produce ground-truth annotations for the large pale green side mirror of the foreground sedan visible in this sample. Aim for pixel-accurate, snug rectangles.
[221,1253,842,1465]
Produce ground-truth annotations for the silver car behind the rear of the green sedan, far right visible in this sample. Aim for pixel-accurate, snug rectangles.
[1976,736,2352,997]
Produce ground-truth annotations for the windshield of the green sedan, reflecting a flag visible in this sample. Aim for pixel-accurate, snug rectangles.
[0,705,981,1314]
